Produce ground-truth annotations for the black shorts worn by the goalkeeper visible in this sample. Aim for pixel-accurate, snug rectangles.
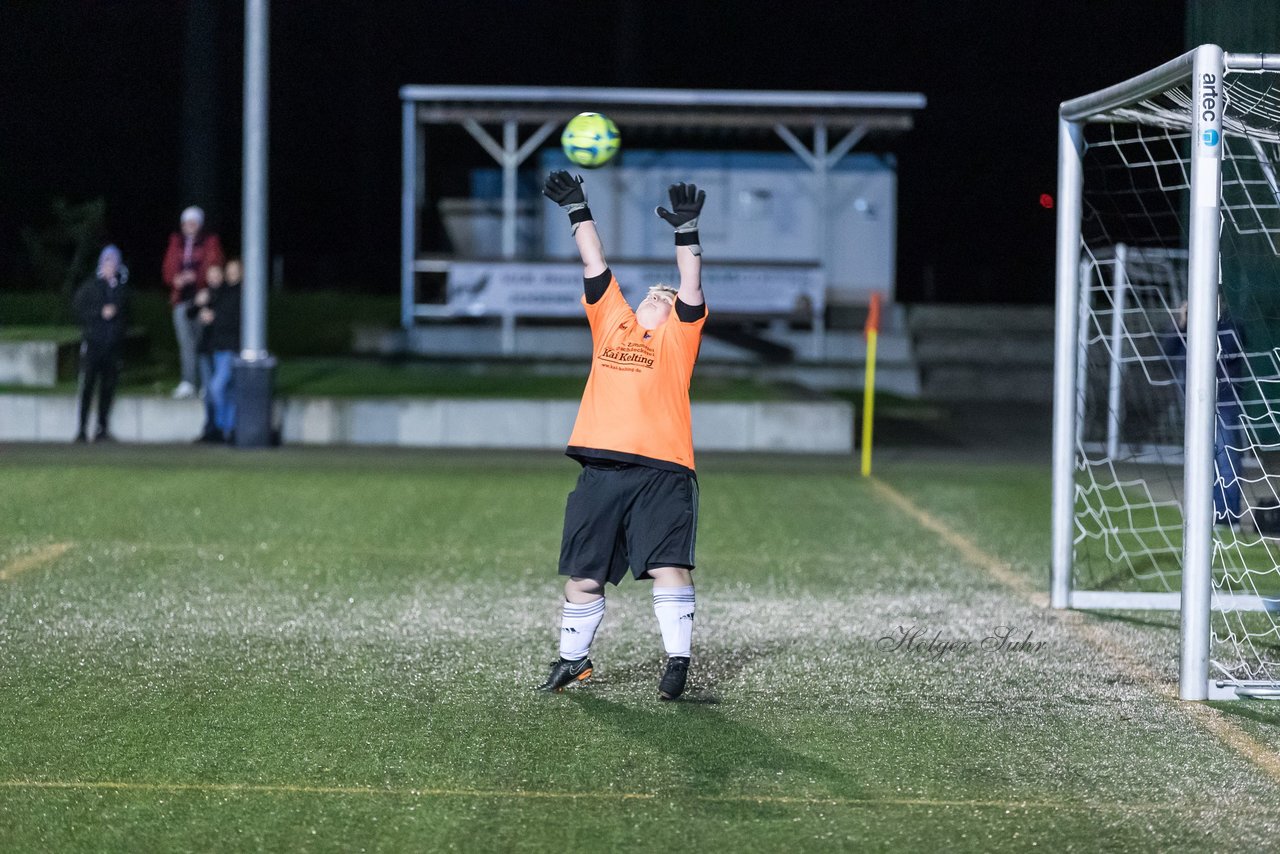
[559,463,698,584]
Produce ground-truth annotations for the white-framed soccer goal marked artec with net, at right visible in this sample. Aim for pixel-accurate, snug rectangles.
[1051,45,1280,699]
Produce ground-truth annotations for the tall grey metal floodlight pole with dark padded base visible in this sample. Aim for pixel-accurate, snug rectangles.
[236,0,275,448]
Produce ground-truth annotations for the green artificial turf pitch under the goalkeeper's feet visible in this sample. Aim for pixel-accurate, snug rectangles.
[0,447,1280,851]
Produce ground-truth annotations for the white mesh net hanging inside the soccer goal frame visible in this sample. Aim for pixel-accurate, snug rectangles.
[1073,73,1280,682]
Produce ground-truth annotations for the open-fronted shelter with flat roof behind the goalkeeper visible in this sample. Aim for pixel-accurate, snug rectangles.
[399,86,925,361]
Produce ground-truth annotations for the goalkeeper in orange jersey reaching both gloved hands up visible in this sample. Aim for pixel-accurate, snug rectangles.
[539,172,707,700]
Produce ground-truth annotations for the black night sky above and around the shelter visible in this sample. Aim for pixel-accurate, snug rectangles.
[0,0,1184,301]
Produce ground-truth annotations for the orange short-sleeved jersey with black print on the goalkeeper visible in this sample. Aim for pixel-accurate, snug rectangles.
[567,273,707,472]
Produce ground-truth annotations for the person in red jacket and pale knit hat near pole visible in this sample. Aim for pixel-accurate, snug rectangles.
[163,205,224,398]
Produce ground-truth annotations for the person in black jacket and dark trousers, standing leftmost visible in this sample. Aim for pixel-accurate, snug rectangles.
[72,246,128,442]
